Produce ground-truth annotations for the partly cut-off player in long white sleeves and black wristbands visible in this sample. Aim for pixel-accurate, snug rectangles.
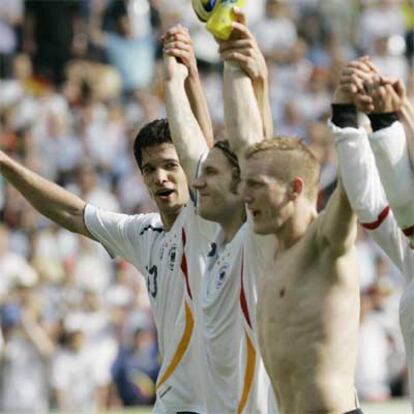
[331,61,414,408]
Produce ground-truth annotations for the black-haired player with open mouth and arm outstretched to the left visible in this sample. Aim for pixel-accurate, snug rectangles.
[0,77,214,414]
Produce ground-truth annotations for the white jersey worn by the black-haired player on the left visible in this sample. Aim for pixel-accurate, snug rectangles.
[85,202,216,414]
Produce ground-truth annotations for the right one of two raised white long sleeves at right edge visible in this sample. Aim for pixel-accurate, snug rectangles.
[369,121,414,242]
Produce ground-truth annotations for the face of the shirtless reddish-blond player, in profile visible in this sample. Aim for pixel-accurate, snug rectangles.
[243,153,293,234]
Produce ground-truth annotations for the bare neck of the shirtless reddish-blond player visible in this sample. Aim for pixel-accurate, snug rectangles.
[276,201,318,252]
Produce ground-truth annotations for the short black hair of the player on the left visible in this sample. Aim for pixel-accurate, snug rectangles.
[134,118,173,171]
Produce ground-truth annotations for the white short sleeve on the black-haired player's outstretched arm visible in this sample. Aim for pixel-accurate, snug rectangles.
[84,204,159,272]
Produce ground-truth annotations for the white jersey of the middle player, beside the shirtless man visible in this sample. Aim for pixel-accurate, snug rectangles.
[202,222,276,414]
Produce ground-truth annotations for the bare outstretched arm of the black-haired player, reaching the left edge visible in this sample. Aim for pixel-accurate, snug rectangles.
[0,151,93,239]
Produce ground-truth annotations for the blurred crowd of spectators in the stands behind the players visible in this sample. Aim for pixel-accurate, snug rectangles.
[0,0,414,413]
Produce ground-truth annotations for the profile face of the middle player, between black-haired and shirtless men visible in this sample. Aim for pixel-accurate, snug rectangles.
[193,148,243,223]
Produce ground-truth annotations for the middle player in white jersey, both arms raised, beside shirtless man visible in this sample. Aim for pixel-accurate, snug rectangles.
[164,18,276,414]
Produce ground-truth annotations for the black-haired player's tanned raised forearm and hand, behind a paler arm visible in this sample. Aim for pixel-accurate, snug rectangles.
[163,25,214,148]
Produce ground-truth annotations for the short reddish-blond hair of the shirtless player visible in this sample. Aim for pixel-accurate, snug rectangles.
[245,136,321,200]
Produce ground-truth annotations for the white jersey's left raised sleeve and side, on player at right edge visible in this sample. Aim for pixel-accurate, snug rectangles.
[331,120,414,409]
